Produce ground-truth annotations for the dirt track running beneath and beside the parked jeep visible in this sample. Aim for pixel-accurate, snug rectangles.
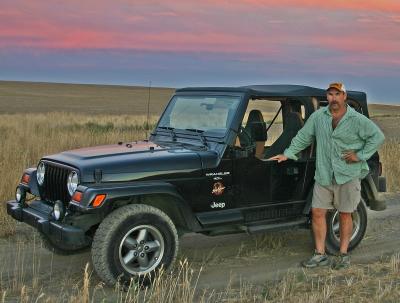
[0,193,400,289]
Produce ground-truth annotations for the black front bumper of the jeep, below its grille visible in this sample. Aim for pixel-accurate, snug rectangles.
[7,200,90,249]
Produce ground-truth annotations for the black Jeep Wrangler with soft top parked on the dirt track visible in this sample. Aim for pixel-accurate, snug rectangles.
[7,85,385,284]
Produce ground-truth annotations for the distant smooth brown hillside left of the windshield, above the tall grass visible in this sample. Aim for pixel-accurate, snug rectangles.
[0,81,174,115]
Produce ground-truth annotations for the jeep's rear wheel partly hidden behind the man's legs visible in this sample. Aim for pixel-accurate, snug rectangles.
[325,200,367,254]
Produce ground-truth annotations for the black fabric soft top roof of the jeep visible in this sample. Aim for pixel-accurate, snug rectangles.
[176,84,368,116]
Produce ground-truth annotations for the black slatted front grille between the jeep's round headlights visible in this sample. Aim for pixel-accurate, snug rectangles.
[41,162,72,202]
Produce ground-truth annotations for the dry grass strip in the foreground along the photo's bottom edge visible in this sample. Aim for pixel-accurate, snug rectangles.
[0,239,400,303]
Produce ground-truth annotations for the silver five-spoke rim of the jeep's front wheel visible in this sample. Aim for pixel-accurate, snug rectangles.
[119,225,165,275]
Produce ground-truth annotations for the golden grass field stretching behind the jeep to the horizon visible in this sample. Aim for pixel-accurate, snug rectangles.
[0,81,400,235]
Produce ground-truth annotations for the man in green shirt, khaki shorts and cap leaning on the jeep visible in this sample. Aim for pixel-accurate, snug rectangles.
[270,83,385,269]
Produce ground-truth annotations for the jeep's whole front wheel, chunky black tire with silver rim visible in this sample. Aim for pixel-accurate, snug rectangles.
[92,204,178,285]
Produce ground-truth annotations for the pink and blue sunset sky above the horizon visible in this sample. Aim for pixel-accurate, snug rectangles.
[0,0,400,104]
